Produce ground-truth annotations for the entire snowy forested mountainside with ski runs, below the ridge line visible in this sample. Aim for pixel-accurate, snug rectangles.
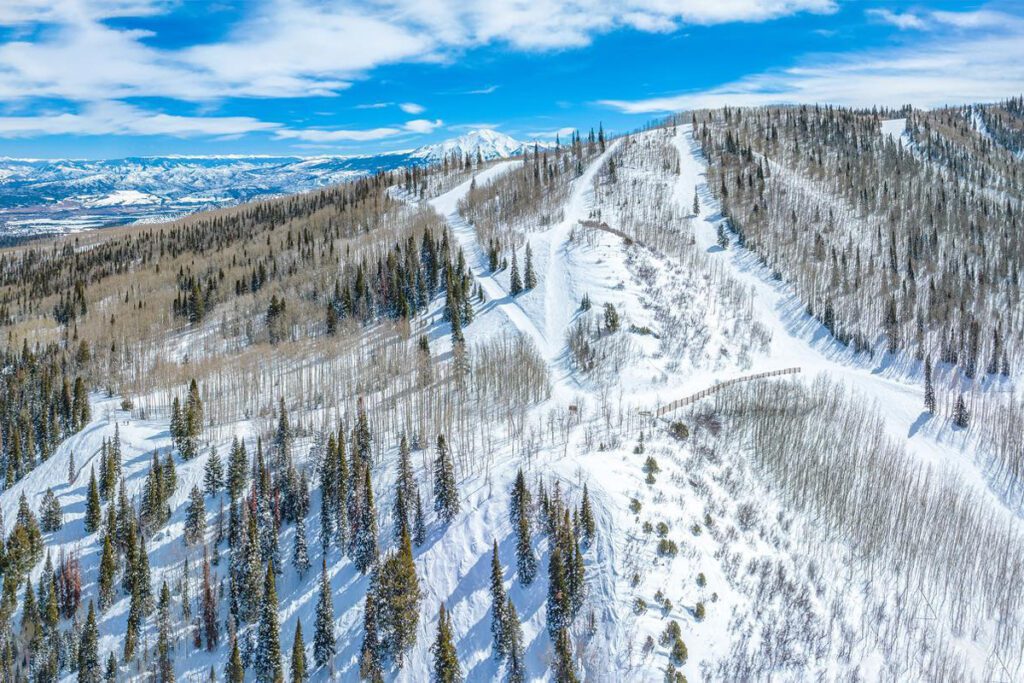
[0,100,1024,683]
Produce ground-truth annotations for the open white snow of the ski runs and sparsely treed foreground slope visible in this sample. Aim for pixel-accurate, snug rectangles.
[0,124,1019,681]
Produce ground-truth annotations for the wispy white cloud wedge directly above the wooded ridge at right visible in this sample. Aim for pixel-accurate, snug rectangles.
[600,20,1024,115]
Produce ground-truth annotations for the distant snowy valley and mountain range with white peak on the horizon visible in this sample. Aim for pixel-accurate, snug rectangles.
[0,129,532,243]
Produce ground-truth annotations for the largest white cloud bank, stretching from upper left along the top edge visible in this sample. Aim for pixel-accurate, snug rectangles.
[0,0,836,104]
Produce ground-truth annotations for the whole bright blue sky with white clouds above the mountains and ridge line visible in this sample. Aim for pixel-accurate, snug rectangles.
[0,0,1024,158]
